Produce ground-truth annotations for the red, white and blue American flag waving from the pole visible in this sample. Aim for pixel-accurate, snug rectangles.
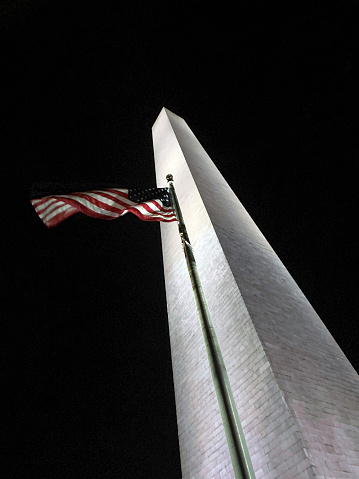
[30,188,176,228]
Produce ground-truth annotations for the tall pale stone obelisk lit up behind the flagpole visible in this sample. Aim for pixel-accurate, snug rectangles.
[153,108,359,479]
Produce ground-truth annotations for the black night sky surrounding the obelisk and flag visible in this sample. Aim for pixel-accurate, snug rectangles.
[0,0,359,479]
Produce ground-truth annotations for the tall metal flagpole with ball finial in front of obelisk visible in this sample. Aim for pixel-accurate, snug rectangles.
[166,175,255,479]
